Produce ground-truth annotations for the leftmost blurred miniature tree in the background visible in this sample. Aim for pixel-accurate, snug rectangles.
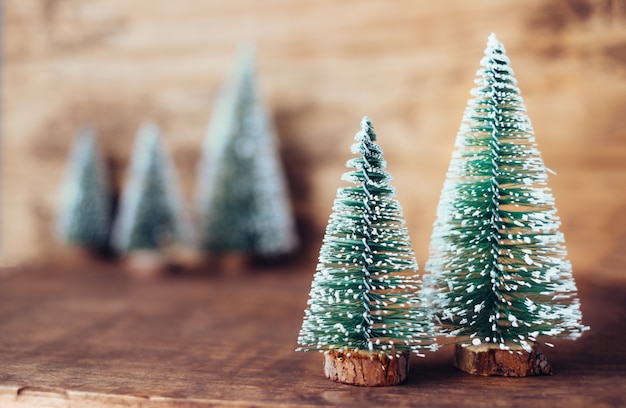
[57,128,111,251]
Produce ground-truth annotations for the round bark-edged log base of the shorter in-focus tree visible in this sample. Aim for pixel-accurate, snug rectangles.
[324,350,409,387]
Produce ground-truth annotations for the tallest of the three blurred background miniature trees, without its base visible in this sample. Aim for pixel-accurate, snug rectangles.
[197,50,297,264]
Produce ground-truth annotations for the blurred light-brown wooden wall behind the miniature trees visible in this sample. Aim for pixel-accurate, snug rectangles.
[0,0,626,279]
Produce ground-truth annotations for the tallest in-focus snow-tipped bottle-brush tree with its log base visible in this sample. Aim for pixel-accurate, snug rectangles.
[424,34,586,376]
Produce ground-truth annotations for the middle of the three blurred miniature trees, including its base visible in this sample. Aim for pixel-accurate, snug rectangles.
[112,123,190,269]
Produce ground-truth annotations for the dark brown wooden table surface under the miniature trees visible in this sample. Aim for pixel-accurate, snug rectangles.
[0,263,626,407]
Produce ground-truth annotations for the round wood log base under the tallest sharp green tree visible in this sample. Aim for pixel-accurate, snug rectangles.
[454,343,552,377]
